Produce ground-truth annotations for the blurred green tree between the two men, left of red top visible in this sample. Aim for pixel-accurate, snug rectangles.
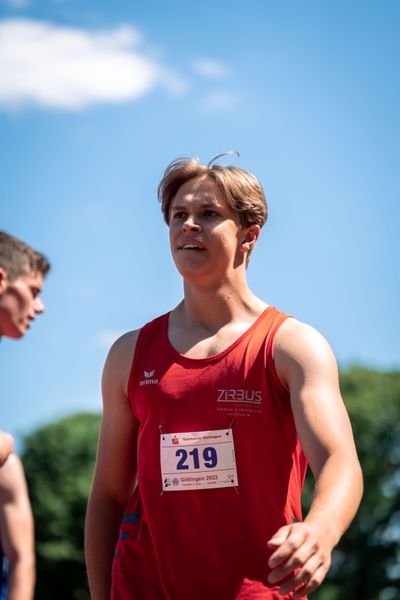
[22,414,100,600]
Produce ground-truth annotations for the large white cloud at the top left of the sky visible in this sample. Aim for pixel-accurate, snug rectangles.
[0,19,183,109]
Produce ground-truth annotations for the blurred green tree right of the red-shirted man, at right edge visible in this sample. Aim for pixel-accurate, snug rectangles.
[304,367,400,600]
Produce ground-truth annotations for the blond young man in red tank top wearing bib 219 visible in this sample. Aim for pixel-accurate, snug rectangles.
[86,159,362,600]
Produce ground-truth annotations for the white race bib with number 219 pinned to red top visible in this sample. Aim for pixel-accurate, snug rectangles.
[160,429,238,492]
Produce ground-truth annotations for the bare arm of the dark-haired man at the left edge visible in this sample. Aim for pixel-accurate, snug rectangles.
[0,454,35,600]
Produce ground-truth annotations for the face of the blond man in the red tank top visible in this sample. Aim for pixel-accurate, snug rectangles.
[170,178,248,279]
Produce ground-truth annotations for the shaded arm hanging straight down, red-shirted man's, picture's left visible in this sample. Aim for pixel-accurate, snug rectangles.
[85,332,138,600]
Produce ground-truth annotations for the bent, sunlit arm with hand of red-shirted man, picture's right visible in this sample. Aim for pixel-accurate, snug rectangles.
[268,319,362,598]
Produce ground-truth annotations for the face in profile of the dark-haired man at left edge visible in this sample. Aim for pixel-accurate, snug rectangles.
[0,269,44,339]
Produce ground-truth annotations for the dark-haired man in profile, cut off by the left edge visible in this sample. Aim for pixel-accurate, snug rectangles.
[0,231,50,600]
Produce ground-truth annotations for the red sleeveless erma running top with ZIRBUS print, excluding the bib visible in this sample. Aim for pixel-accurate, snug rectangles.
[111,307,306,600]
